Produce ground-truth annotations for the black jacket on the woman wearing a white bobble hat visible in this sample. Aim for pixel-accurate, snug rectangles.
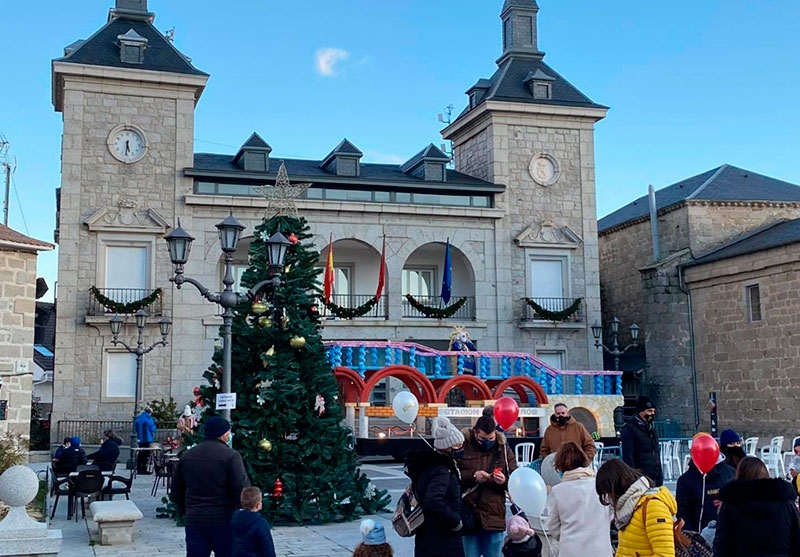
[406,450,464,557]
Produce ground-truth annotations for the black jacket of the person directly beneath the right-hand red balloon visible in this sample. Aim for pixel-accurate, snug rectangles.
[675,461,734,532]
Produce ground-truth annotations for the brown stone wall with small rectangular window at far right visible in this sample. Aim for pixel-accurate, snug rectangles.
[686,244,800,440]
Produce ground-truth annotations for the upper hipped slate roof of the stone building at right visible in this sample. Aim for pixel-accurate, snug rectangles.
[597,164,800,232]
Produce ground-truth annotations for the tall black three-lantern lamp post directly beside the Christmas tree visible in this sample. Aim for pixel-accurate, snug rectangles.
[164,214,290,421]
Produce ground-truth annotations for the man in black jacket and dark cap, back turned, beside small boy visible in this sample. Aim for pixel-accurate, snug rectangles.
[172,416,250,557]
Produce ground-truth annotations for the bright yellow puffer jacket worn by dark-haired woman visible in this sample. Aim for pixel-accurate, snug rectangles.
[616,487,678,557]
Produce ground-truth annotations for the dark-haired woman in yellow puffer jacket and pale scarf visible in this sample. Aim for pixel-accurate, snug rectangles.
[595,459,678,557]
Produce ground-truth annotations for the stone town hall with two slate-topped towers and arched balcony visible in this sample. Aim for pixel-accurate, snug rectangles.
[53,0,606,420]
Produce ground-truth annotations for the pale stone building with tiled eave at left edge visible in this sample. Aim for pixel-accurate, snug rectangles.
[0,224,54,437]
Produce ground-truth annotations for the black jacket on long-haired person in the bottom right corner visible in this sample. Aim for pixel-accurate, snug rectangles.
[714,478,800,557]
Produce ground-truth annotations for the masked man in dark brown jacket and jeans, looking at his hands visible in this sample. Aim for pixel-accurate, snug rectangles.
[459,412,517,557]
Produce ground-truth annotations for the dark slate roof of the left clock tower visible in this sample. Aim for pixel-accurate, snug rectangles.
[55,11,208,75]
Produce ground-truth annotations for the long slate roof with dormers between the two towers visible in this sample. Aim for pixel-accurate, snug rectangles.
[185,154,505,193]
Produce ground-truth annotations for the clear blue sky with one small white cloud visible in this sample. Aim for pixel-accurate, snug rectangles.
[0,0,800,299]
